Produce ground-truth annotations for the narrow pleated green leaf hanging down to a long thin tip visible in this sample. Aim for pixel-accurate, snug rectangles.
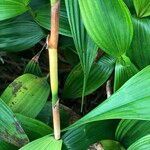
[65,0,98,111]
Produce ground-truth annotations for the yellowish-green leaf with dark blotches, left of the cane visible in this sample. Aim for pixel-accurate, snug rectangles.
[1,74,50,118]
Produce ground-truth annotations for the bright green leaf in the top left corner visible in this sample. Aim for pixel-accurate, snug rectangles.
[0,0,30,21]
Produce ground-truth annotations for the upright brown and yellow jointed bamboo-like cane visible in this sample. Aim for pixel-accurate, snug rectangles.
[48,0,60,140]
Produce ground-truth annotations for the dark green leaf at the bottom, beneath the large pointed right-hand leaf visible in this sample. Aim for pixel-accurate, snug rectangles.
[62,120,118,150]
